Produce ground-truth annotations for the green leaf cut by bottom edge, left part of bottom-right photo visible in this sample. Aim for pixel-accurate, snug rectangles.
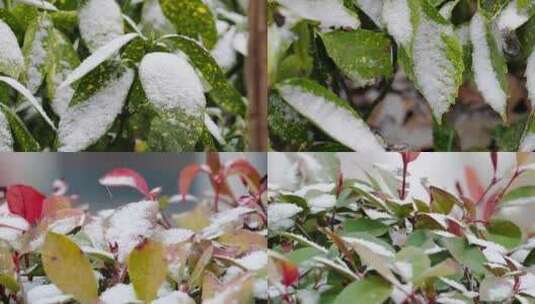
[334,276,392,304]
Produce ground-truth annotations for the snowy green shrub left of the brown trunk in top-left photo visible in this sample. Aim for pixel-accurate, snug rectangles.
[0,0,247,152]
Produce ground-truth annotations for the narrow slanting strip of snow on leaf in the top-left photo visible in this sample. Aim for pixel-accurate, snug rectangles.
[58,33,139,89]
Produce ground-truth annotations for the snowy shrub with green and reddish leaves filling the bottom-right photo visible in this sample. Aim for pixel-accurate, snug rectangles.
[268,153,535,304]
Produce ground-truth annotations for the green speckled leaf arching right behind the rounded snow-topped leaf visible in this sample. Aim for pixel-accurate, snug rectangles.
[166,36,246,116]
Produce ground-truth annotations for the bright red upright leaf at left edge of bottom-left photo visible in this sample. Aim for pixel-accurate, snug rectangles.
[6,185,45,224]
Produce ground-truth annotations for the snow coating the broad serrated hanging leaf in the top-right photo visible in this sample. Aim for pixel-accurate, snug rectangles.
[412,13,458,119]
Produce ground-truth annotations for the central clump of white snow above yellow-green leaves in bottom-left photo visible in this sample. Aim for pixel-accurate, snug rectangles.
[104,201,158,263]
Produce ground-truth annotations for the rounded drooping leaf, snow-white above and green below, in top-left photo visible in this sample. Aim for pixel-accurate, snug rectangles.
[139,53,206,151]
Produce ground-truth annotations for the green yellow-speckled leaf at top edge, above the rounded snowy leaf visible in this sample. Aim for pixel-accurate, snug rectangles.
[160,0,217,49]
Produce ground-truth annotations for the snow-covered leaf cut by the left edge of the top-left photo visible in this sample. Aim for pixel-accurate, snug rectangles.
[0,19,24,78]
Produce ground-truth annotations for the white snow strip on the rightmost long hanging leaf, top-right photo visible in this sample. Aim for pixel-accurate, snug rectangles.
[470,14,507,117]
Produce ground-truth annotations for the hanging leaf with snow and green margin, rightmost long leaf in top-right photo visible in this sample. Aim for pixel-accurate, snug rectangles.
[470,14,507,120]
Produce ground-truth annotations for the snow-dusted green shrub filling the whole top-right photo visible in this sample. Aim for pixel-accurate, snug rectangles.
[268,0,535,152]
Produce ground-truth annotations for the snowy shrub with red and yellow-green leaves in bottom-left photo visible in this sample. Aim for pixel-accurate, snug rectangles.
[0,154,268,304]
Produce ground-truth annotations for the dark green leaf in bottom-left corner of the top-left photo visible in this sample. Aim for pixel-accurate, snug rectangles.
[0,104,41,152]
